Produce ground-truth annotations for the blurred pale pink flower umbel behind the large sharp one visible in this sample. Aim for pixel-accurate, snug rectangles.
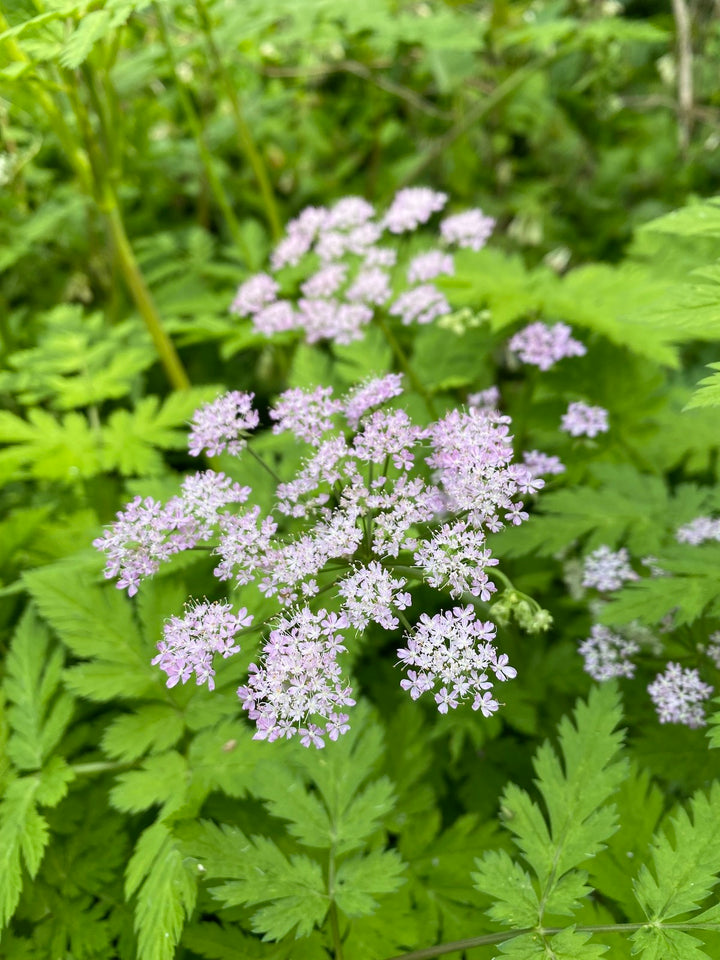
[230,187,494,344]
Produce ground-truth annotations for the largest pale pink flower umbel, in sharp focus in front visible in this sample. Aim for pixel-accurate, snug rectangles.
[95,374,556,747]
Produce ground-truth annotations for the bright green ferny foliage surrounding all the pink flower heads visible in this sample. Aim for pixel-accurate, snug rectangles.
[5,0,720,960]
